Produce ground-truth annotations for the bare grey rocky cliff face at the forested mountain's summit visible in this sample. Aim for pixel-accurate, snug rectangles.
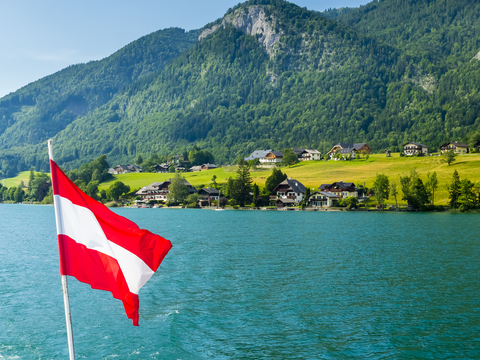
[198,6,281,57]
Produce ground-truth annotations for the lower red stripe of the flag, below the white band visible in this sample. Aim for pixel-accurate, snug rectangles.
[58,235,139,326]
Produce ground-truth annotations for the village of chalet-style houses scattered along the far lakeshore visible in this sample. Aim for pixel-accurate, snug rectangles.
[109,141,480,210]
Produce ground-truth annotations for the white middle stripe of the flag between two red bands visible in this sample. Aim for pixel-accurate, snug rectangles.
[54,195,154,294]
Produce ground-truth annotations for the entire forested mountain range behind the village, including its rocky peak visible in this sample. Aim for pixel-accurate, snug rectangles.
[0,0,480,176]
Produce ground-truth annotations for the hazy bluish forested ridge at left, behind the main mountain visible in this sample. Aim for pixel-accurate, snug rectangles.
[0,28,198,175]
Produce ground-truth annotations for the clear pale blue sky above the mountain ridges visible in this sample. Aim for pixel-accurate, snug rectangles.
[0,0,369,97]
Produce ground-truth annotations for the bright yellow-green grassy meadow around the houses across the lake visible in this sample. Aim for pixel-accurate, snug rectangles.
[5,153,480,205]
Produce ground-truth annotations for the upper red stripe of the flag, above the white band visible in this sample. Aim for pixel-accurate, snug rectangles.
[50,160,172,271]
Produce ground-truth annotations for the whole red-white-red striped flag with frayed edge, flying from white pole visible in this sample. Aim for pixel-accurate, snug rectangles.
[50,160,172,326]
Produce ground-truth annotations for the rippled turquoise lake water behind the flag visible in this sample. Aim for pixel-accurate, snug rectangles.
[0,205,480,359]
